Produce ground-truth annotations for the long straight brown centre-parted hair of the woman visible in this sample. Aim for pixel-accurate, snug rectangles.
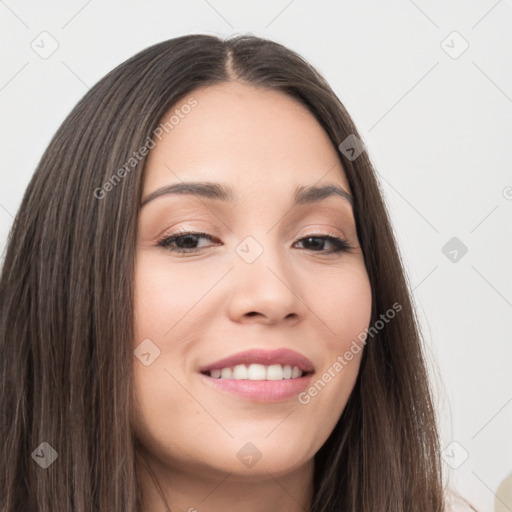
[0,35,444,512]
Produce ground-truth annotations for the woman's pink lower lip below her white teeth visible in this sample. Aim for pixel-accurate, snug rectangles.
[200,373,313,402]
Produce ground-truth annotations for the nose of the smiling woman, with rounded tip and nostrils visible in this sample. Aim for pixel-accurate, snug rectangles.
[227,238,308,324]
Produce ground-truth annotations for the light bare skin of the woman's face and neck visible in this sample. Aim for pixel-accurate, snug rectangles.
[132,82,371,512]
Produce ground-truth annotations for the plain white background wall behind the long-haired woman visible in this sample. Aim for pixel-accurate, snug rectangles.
[0,0,512,512]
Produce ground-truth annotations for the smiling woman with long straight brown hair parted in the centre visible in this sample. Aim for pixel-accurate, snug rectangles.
[0,35,474,512]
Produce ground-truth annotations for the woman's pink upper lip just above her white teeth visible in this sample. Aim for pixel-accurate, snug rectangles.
[199,348,314,373]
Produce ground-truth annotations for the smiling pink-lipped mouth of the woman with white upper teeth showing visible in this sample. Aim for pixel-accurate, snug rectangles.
[199,349,315,402]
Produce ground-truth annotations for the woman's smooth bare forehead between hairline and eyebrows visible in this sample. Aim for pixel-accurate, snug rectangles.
[144,82,349,194]
